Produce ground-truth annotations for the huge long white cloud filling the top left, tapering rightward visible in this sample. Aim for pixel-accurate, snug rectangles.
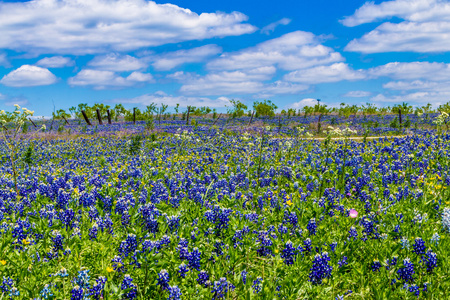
[0,0,256,54]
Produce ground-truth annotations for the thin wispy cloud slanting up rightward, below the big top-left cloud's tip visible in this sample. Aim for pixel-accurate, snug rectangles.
[152,45,222,71]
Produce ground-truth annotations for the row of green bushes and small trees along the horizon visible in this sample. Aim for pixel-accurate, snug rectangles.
[53,99,450,121]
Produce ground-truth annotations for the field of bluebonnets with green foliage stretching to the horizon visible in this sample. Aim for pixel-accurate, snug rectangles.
[0,102,450,299]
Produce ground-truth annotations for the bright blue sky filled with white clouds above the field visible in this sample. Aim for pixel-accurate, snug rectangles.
[0,0,450,116]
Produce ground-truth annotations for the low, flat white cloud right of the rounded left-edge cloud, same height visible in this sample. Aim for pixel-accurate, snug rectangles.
[68,69,153,89]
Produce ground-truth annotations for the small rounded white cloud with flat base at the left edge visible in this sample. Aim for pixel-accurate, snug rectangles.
[0,65,57,87]
